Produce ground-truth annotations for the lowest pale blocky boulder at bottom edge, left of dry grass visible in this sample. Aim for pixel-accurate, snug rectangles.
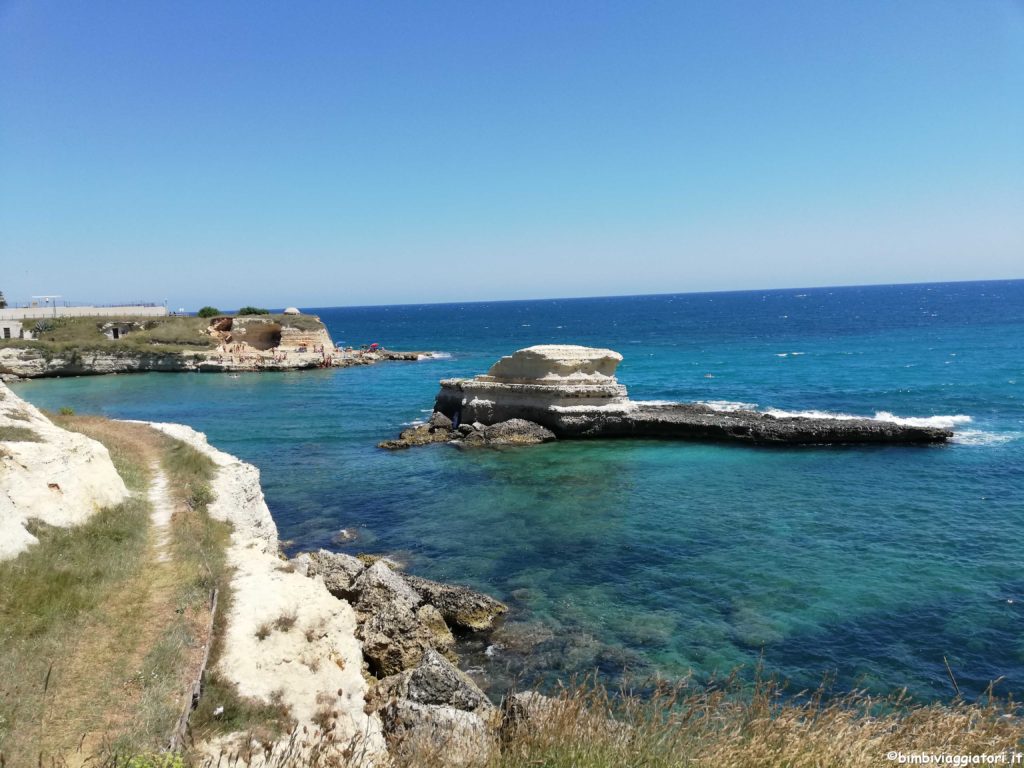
[381,698,496,768]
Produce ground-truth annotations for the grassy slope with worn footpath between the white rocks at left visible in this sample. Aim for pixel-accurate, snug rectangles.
[0,415,238,765]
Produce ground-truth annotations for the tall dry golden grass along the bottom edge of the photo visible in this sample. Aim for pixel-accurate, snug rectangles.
[172,680,1024,768]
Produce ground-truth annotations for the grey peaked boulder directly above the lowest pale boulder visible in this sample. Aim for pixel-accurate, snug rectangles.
[374,649,495,719]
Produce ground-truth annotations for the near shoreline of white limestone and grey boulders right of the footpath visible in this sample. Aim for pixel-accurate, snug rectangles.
[152,424,548,767]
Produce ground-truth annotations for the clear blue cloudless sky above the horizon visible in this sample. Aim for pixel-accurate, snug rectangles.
[0,0,1024,308]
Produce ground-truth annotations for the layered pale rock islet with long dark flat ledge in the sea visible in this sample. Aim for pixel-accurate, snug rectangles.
[381,344,952,449]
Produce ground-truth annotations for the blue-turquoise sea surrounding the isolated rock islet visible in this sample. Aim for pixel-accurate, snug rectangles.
[16,281,1024,698]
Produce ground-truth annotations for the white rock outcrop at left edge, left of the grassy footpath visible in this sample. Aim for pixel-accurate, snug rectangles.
[0,384,128,560]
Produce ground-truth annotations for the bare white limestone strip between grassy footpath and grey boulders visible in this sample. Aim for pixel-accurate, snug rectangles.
[152,424,386,766]
